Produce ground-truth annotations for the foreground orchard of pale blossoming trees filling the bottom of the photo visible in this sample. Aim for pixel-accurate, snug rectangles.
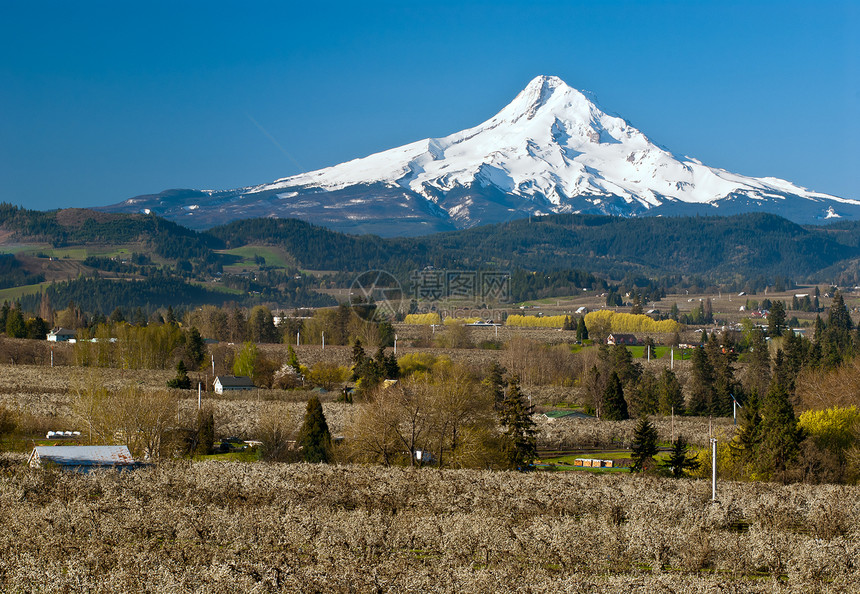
[0,459,860,592]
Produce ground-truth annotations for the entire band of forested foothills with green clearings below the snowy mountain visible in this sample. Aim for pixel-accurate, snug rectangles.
[0,204,860,313]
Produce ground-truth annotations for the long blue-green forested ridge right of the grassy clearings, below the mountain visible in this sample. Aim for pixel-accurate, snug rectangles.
[203,213,860,284]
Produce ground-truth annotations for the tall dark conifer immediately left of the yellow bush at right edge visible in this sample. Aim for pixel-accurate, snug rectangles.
[758,385,803,482]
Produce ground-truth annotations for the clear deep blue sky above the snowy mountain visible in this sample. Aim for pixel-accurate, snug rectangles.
[0,0,860,209]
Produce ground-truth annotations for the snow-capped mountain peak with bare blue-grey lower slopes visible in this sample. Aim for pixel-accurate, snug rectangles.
[108,76,860,236]
